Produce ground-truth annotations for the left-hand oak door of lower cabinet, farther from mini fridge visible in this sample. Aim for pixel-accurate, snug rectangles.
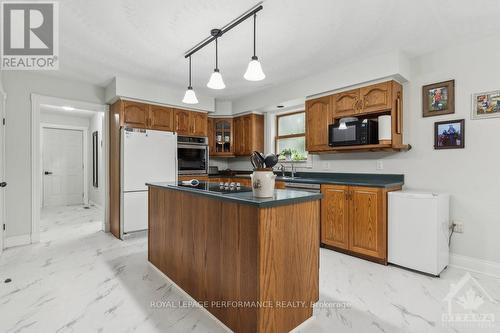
[321,185,349,250]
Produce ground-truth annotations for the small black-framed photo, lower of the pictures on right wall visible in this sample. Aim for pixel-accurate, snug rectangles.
[434,119,465,149]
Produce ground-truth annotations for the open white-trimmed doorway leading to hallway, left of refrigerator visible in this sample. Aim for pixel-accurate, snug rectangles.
[31,94,109,243]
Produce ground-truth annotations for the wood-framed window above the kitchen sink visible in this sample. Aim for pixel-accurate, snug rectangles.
[276,111,307,161]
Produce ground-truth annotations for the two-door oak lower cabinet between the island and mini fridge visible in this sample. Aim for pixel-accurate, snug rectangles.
[321,185,401,264]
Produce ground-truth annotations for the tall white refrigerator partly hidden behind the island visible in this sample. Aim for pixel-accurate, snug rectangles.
[120,128,177,239]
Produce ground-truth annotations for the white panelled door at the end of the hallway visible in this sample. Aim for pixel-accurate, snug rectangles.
[42,128,84,207]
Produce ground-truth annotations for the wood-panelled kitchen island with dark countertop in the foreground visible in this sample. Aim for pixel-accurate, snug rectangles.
[148,183,321,332]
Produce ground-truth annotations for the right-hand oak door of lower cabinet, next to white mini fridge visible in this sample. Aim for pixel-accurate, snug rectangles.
[349,186,387,259]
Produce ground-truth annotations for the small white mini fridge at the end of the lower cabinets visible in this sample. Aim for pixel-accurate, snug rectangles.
[387,191,450,276]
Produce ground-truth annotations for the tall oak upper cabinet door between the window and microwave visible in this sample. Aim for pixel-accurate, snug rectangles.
[306,96,331,152]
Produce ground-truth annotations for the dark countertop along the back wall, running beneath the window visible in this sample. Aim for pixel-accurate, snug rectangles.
[210,171,404,188]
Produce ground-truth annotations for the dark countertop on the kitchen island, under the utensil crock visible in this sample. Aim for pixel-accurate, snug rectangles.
[146,182,322,208]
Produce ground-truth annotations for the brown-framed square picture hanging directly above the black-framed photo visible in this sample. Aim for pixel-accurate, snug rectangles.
[422,80,455,117]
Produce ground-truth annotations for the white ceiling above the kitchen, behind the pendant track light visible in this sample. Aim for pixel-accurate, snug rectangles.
[52,0,500,99]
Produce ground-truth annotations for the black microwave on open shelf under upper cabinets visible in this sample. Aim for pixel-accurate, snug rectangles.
[328,119,378,147]
